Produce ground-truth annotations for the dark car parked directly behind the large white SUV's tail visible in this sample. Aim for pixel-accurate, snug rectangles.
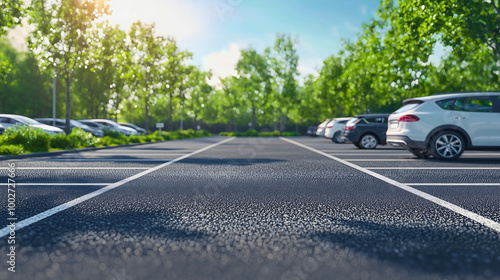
[342,114,389,149]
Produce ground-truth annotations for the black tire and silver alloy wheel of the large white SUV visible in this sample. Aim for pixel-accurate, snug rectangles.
[429,131,465,160]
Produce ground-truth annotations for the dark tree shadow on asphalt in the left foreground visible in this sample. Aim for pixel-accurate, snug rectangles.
[7,208,211,254]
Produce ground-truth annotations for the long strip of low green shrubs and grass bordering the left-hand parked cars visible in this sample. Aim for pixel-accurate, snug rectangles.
[0,126,212,155]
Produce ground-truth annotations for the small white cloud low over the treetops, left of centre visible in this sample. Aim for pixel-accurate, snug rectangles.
[203,44,241,86]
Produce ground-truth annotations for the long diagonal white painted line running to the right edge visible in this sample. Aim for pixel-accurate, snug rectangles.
[280,137,500,233]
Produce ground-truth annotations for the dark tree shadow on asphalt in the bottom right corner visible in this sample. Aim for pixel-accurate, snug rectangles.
[308,220,500,278]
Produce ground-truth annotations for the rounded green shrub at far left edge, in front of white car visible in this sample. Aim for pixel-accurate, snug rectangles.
[3,125,50,152]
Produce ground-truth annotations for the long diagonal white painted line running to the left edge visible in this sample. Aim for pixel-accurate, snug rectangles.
[0,137,235,238]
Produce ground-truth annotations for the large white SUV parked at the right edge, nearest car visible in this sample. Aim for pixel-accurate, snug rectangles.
[387,92,500,159]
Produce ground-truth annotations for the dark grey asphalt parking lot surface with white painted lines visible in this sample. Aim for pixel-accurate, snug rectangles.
[0,137,500,280]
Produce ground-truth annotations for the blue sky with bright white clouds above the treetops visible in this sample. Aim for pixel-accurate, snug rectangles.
[103,0,379,83]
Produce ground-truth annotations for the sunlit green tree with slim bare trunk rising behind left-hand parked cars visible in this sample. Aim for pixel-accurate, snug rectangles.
[29,0,109,133]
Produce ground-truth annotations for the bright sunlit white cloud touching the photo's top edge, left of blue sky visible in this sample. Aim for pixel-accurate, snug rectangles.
[108,0,204,41]
